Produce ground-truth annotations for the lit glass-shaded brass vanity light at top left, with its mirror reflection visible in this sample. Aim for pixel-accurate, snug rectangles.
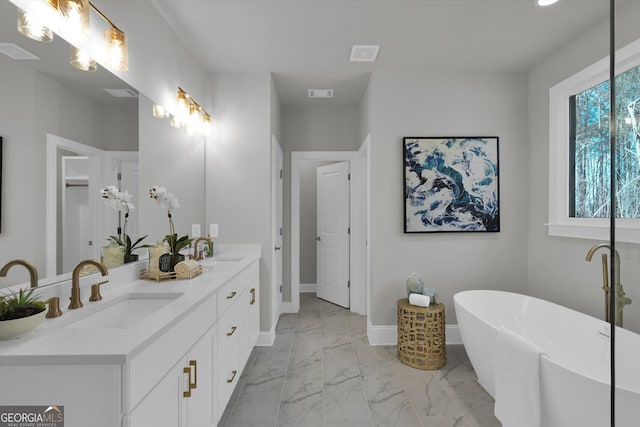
[18,0,129,71]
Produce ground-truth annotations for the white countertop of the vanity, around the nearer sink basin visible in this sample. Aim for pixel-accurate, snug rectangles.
[0,245,260,366]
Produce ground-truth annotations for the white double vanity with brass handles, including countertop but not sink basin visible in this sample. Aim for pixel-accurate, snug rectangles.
[0,249,259,427]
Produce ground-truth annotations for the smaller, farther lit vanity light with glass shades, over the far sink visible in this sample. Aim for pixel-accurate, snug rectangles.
[153,87,211,136]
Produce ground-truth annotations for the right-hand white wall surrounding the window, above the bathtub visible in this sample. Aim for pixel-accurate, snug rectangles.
[527,2,640,332]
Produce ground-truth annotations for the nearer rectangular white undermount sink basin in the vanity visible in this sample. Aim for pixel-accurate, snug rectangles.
[66,293,182,329]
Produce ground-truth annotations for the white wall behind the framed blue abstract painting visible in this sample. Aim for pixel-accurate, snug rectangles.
[368,72,528,325]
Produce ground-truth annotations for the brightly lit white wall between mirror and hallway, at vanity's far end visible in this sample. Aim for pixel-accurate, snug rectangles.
[206,73,272,331]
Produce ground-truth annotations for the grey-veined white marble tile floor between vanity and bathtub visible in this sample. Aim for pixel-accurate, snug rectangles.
[218,294,500,427]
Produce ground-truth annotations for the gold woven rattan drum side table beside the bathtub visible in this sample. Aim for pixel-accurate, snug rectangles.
[397,298,447,370]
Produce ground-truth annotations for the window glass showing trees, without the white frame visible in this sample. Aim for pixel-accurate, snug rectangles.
[569,66,640,218]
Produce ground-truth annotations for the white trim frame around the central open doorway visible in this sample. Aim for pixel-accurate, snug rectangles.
[286,151,367,314]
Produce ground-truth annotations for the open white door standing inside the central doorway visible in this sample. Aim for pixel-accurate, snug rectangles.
[316,162,350,308]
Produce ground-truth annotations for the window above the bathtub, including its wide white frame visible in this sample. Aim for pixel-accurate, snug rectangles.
[549,40,640,243]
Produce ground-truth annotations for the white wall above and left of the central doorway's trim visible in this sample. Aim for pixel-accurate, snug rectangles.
[281,107,361,301]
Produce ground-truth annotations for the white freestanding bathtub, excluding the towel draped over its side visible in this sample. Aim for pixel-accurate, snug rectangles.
[454,290,640,427]
